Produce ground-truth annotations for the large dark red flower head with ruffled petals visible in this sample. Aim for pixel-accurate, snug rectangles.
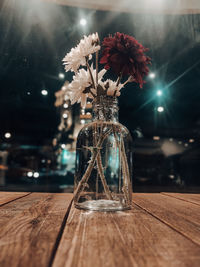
[100,32,151,88]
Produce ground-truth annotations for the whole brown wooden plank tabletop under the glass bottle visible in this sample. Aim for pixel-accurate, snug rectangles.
[0,192,200,267]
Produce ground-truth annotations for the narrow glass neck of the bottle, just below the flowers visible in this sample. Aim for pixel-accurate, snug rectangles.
[93,96,119,122]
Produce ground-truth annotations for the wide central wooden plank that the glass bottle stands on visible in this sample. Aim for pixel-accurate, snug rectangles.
[53,205,200,267]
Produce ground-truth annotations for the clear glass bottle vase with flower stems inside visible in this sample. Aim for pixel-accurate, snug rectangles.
[74,96,132,211]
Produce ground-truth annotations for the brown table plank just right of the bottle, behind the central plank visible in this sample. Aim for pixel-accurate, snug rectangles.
[133,194,200,245]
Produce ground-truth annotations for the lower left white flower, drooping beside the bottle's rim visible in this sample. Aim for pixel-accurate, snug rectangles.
[68,66,106,107]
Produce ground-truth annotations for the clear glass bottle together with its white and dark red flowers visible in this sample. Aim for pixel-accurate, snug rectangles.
[63,32,151,211]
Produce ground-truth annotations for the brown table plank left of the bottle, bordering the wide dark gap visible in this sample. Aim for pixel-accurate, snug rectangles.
[0,193,72,267]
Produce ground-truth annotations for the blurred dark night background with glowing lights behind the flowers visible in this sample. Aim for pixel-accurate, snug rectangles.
[0,0,200,192]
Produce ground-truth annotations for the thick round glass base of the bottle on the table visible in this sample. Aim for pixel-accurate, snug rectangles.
[75,199,131,211]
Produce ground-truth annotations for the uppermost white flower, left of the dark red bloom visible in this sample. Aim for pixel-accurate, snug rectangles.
[63,33,101,72]
